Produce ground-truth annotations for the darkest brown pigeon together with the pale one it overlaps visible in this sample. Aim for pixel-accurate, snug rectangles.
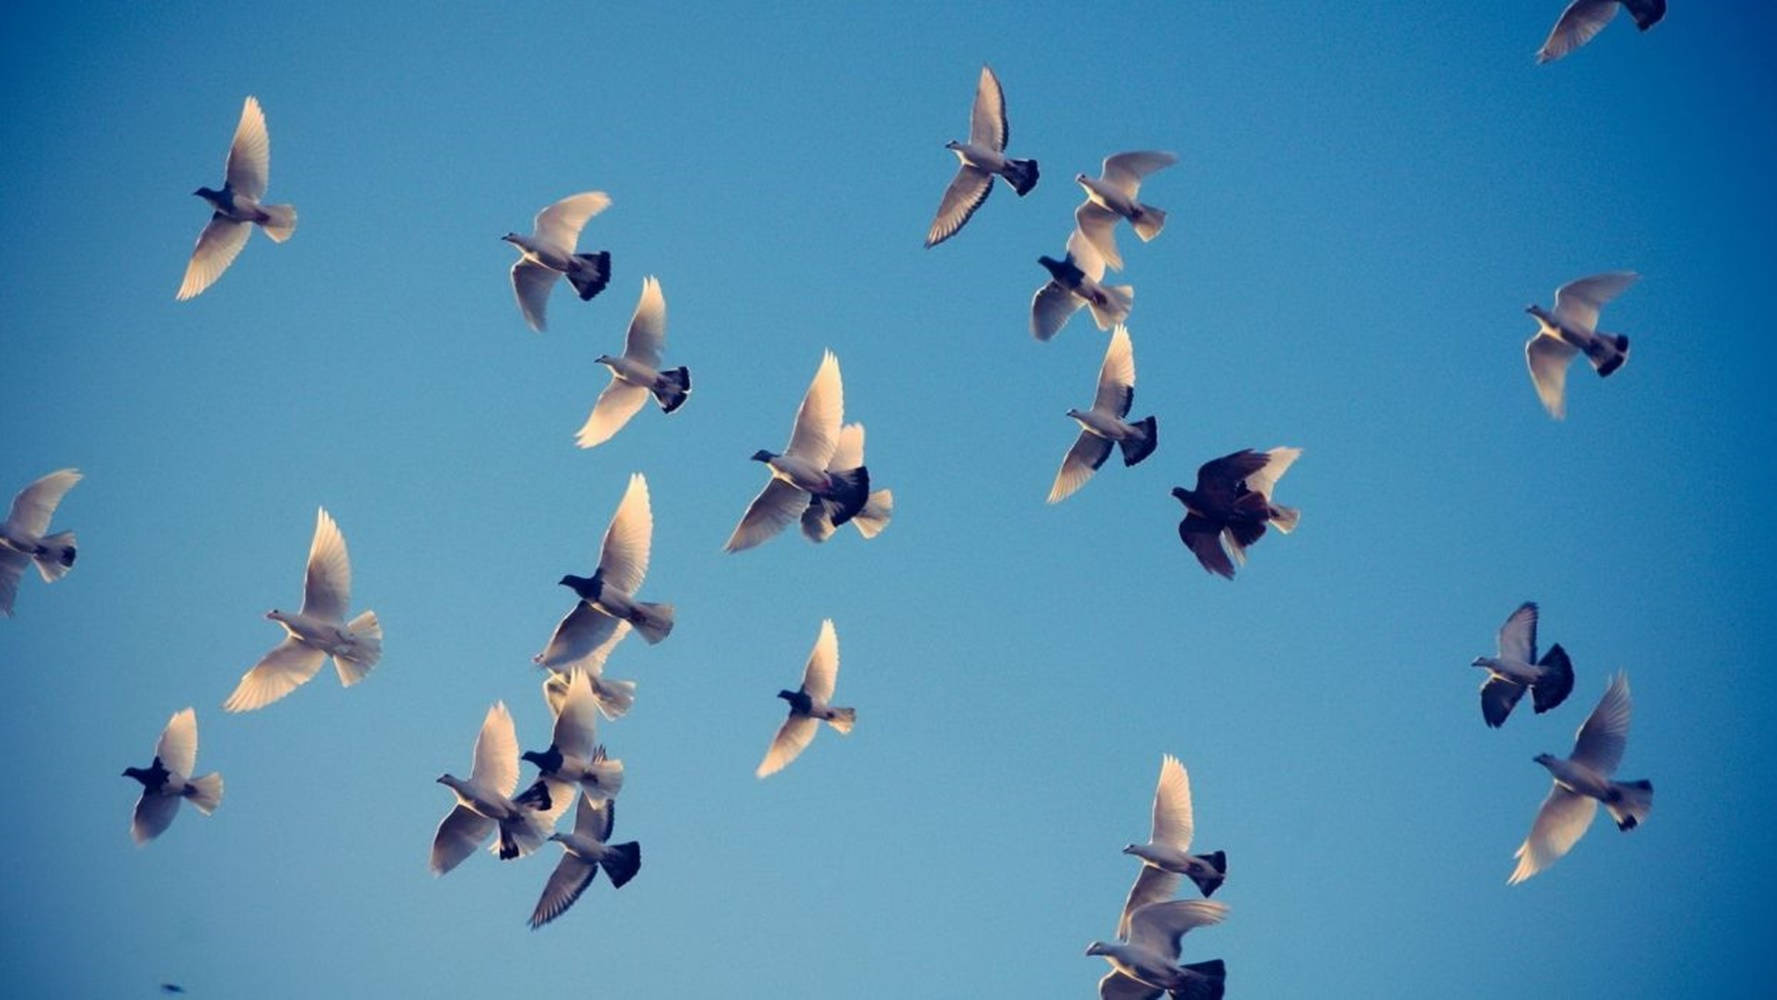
[1173,448,1303,579]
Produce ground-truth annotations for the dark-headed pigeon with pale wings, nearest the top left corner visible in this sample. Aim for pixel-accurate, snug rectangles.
[178,98,297,302]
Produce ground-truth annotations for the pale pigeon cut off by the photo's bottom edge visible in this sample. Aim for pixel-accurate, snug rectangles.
[1086,899,1228,1000]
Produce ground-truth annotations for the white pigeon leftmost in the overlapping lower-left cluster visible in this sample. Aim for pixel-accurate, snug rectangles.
[432,702,569,876]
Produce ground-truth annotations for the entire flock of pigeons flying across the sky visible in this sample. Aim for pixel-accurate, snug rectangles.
[0,0,1665,1000]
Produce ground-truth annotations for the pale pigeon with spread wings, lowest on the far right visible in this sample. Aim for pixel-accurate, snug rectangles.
[1507,673,1654,885]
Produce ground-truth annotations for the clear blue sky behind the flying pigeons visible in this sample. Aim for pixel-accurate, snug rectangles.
[0,0,1777,998]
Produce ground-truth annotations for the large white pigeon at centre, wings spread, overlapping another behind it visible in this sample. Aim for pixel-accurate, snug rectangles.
[723,352,871,552]
